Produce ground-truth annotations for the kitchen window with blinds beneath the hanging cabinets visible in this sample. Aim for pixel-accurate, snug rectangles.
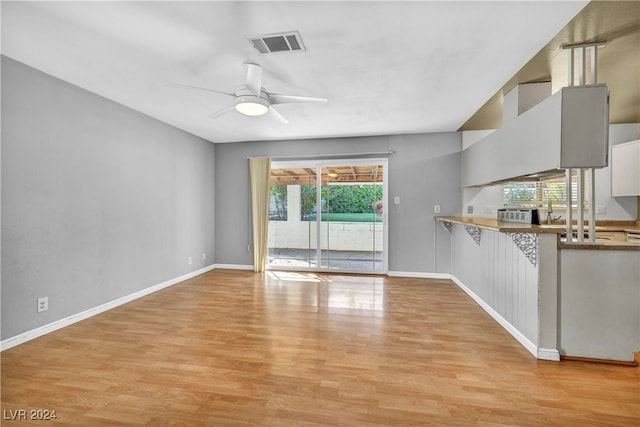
[503,171,589,211]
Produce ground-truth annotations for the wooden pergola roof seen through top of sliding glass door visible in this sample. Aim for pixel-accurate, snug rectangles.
[271,165,383,185]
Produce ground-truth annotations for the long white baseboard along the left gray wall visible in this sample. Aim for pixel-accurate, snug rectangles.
[0,264,216,351]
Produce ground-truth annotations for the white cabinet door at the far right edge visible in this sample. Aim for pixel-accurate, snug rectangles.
[611,140,640,197]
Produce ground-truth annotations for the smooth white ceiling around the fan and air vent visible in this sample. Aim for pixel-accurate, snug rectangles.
[2,1,587,142]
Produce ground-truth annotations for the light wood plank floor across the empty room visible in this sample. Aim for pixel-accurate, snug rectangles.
[1,270,640,427]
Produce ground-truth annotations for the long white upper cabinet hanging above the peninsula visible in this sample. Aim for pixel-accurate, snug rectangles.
[462,84,609,187]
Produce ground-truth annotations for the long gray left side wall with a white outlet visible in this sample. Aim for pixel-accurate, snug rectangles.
[1,57,218,339]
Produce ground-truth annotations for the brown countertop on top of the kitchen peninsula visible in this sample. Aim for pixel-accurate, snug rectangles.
[434,216,640,250]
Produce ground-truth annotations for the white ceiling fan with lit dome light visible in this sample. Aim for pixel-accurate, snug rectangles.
[174,62,328,123]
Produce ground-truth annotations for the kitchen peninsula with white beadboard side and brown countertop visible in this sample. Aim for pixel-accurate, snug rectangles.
[435,217,640,362]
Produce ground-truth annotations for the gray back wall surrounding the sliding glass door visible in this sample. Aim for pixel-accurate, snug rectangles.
[215,132,462,273]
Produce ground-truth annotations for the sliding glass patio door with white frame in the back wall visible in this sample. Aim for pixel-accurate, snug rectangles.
[267,159,387,273]
